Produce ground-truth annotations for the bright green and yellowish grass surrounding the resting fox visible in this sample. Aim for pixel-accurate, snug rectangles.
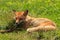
[0,0,60,40]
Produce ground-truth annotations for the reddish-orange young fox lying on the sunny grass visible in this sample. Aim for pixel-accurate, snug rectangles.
[14,10,56,32]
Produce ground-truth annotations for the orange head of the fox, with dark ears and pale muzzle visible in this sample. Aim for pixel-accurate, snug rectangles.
[13,10,28,24]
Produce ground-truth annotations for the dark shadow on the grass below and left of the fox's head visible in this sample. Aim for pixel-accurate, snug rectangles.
[0,20,25,33]
